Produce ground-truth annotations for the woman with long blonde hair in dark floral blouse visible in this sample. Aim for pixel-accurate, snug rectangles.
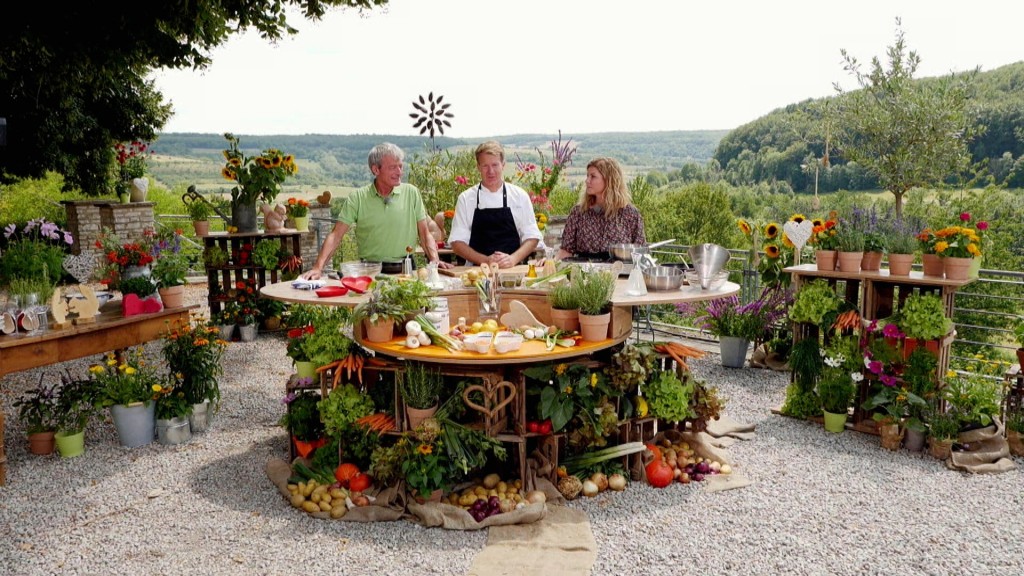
[558,158,647,260]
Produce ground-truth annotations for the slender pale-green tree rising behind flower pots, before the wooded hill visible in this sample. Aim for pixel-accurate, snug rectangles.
[836,19,982,215]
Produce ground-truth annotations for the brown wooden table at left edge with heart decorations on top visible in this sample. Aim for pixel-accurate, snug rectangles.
[0,300,199,486]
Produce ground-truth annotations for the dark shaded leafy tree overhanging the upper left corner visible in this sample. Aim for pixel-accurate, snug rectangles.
[0,0,387,196]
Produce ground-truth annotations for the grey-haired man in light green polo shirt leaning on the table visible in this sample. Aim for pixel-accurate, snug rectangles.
[302,142,451,280]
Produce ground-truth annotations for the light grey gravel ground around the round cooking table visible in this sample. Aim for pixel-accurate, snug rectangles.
[0,289,1024,576]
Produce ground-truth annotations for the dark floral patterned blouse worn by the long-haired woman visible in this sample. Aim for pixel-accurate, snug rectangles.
[561,204,647,254]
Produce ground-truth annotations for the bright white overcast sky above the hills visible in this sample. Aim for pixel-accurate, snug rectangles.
[156,0,1024,137]
